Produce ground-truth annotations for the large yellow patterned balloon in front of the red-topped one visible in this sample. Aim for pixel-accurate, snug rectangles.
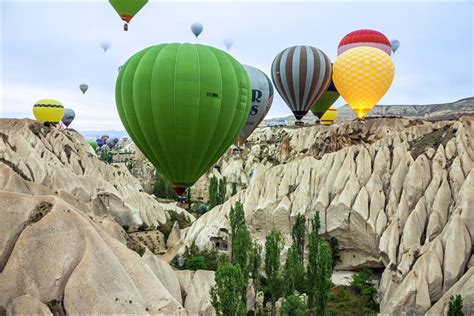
[333,46,395,120]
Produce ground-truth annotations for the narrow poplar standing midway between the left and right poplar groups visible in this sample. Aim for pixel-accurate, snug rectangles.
[265,228,283,316]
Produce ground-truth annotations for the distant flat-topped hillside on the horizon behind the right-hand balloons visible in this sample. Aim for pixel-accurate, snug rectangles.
[264,97,474,124]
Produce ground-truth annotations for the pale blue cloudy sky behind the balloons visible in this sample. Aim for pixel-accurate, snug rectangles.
[0,0,474,131]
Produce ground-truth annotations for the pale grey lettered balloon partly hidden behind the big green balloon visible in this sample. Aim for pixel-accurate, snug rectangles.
[235,65,273,146]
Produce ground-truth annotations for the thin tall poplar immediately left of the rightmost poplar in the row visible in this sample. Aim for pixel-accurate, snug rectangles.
[306,212,320,310]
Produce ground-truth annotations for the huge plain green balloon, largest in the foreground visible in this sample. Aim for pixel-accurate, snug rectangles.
[115,43,252,195]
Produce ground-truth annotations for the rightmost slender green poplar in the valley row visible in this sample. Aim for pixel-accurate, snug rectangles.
[316,240,332,314]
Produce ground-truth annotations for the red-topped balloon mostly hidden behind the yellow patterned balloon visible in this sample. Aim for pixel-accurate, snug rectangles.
[337,29,392,56]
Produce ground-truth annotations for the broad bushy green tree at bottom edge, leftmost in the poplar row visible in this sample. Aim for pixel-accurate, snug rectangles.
[210,262,246,316]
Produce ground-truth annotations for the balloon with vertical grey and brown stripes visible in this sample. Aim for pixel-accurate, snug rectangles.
[272,46,332,124]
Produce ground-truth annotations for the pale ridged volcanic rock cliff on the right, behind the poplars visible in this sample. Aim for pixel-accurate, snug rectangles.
[185,118,474,313]
